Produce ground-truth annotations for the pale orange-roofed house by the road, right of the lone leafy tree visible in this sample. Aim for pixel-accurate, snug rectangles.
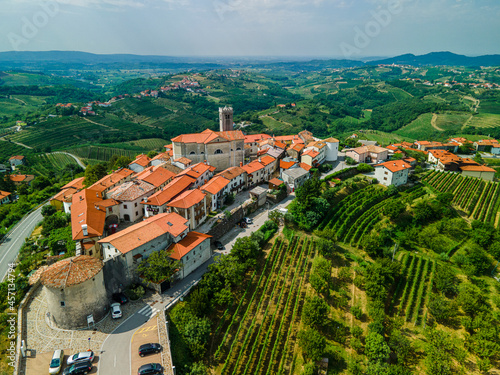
[167,232,212,280]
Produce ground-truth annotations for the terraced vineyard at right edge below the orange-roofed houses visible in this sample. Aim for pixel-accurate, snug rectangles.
[423,171,500,227]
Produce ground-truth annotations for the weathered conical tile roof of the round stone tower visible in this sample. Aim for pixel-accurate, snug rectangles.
[40,255,102,289]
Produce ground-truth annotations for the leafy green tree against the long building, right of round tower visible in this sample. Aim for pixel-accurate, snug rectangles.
[137,250,182,283]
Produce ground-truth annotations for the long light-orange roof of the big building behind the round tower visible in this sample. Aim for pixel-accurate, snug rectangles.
[98,212,188,254]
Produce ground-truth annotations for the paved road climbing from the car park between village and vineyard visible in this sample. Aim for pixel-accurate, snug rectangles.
[98,195,295,375]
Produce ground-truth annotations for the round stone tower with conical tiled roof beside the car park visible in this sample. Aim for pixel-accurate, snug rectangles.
[40,255,109,329]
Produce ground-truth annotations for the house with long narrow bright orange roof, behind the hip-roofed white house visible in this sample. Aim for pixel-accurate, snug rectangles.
[141,176,196,217]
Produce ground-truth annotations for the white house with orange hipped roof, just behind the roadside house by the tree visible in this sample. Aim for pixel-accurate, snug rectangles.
[167,189,208,230]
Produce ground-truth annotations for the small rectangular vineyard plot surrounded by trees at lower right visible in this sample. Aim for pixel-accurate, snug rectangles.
[391,253,436,325]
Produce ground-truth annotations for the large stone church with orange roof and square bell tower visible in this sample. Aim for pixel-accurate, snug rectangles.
[172,107,245,171]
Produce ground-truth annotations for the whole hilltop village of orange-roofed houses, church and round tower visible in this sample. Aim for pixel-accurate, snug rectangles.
[0,107,500,329]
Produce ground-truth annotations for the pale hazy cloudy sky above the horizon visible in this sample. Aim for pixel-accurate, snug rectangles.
[0,0,500,58]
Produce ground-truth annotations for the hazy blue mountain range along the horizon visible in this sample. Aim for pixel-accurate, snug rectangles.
[0,51,500,71]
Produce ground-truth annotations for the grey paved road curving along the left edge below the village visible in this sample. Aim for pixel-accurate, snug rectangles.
[0,207,43,280]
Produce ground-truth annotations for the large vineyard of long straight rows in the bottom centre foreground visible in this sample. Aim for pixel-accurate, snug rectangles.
[214,237,314,375]
